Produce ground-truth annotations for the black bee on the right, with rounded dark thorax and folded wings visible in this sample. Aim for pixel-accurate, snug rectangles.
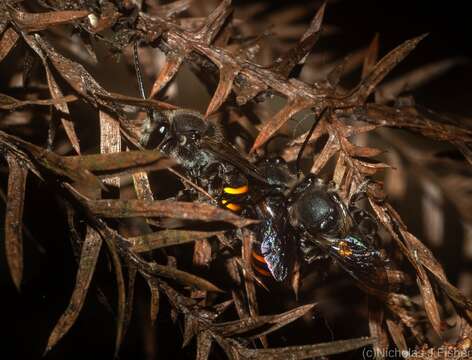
[288,176,393,292]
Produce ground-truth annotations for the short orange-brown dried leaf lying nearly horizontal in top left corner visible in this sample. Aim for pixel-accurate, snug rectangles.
[10,9,90,32]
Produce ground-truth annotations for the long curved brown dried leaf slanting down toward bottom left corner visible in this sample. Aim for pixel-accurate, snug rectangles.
[45,226,102,352]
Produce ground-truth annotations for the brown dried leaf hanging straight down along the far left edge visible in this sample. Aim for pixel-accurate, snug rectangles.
[5,154,28,291]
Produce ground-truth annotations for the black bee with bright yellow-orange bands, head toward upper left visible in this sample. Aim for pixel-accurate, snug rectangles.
[134,44,296,281]
